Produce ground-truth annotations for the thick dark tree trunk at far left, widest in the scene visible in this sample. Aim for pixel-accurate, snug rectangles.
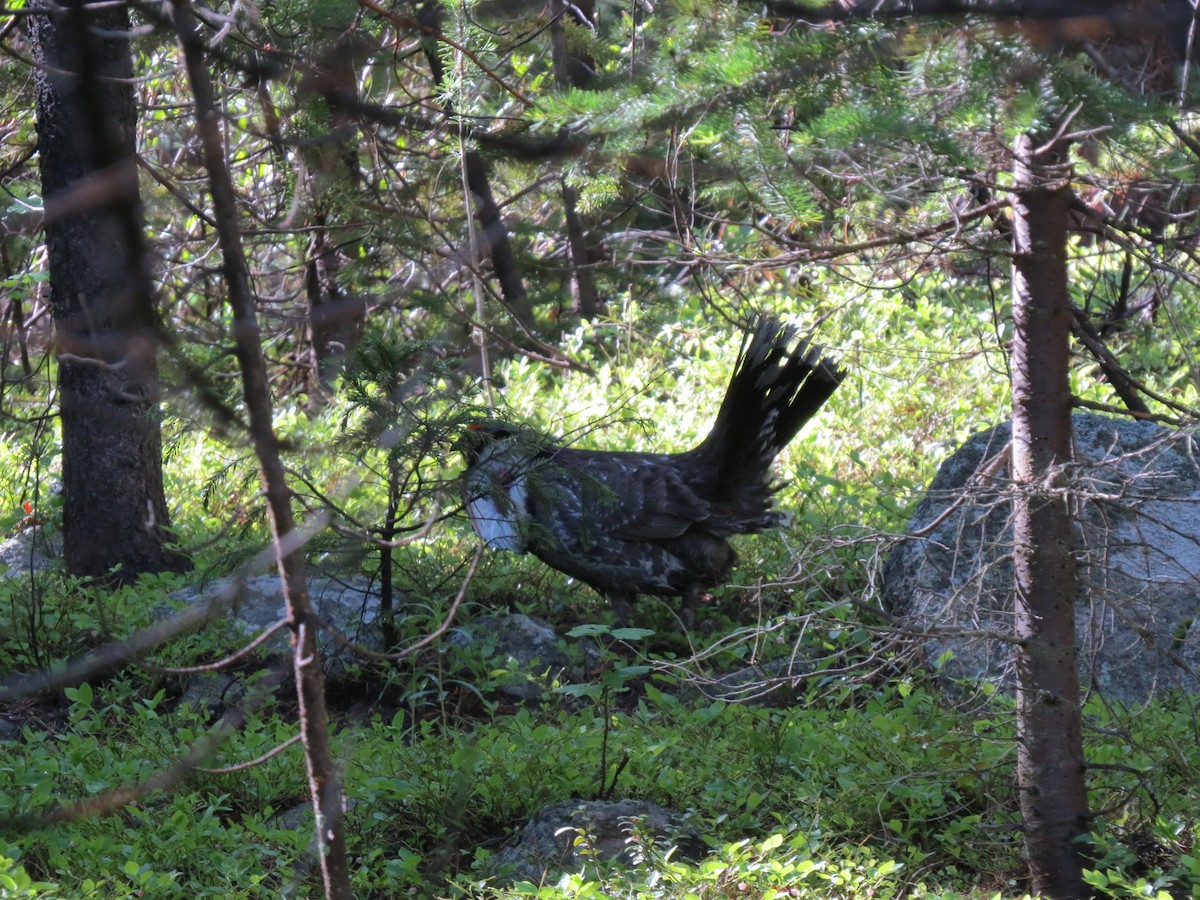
[29,0,190,582]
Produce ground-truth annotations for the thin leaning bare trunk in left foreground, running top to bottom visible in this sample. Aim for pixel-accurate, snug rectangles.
[174,0,353,900]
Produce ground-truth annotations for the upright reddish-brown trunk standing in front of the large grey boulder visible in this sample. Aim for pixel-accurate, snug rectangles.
[1013,134,1088,900]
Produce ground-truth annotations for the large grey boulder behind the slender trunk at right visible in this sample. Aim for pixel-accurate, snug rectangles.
[884,415,1200,703]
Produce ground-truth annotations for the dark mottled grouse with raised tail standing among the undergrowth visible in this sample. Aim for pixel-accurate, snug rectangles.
[462,319,844,617]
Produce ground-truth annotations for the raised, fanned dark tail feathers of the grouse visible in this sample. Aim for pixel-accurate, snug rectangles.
[696,318,846,487]
